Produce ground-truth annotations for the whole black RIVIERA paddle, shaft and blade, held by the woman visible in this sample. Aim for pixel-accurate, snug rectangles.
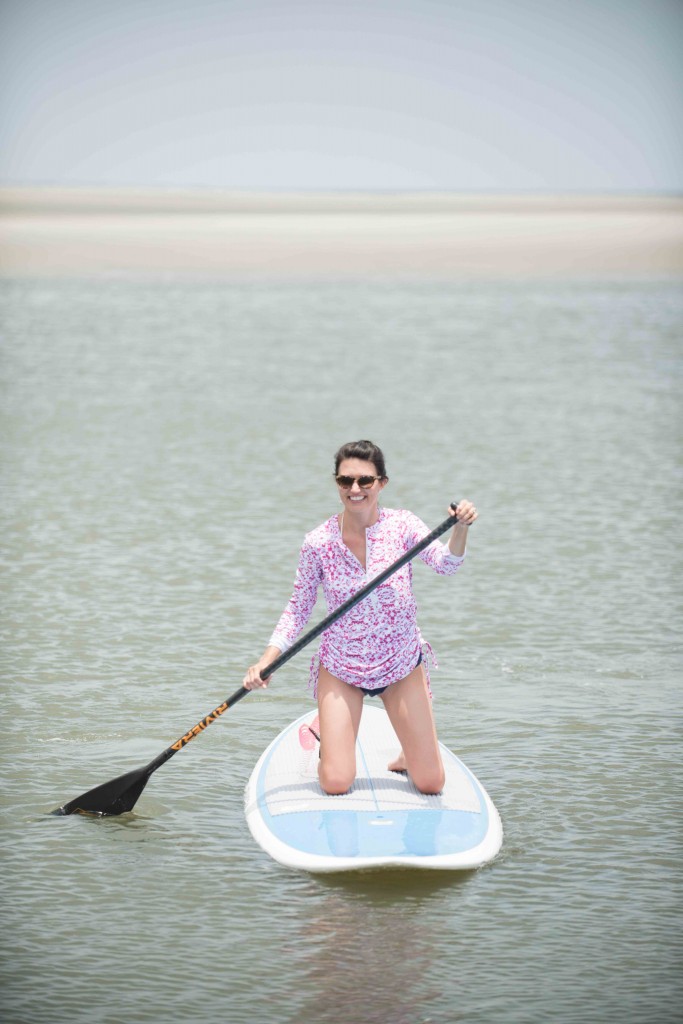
[52,502,464,817]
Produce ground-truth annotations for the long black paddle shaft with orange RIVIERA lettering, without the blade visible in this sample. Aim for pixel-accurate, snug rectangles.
[146,505,458,774]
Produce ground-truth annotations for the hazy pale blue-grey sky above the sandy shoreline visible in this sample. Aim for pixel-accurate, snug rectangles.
[0,0,683,190]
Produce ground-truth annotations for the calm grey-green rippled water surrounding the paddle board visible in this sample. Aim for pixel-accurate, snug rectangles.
[2,282,683,1024]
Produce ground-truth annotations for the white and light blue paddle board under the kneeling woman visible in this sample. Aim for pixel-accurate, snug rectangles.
[245,706,503,872]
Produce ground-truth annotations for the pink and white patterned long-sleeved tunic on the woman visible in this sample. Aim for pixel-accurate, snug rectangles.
[269,508,464,694]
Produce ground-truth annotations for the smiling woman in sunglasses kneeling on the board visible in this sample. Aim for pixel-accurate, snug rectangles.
[244,440,477,795]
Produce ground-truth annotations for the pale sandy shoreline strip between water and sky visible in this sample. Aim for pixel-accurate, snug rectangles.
[0,187,683,281]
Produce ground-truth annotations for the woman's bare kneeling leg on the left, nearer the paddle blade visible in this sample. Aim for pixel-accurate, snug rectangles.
[317,666,362,796]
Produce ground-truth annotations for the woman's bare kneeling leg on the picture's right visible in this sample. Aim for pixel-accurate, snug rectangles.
[382,665,445,794]
